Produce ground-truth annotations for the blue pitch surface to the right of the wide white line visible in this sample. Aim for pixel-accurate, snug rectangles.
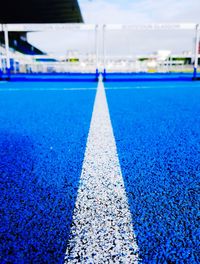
[106,82,200,264]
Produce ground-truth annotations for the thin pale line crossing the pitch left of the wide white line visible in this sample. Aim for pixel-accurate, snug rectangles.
[0,88,96,92]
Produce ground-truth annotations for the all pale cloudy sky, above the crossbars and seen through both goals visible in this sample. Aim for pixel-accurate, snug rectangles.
[28,0,200,56]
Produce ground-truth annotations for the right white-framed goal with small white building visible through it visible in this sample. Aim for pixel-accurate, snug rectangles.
[102,23,200,78]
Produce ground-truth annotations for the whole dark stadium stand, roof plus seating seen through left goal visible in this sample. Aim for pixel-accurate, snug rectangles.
[0,0,83,55]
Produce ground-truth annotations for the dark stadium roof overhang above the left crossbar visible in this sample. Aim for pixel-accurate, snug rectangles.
[0,0,83,24]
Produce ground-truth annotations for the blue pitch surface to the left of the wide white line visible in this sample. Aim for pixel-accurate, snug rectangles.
[0,82,96,263]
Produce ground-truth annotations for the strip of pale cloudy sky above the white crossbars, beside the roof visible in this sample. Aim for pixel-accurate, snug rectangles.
[79,0,200,24]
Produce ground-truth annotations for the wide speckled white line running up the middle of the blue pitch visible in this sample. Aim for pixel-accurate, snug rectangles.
[65,75,138,264]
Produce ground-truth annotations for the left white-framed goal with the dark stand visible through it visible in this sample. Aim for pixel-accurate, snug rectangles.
[0,24,99,78]
